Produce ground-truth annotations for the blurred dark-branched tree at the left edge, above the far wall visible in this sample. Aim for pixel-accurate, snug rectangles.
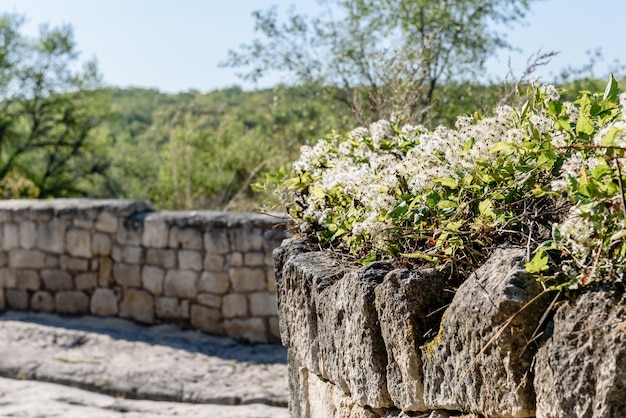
[0,14,108,198]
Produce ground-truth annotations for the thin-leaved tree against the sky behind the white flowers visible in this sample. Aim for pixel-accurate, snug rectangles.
[223,0,533,123]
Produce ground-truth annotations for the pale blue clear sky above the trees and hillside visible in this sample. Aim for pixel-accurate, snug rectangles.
[0,0,626,93]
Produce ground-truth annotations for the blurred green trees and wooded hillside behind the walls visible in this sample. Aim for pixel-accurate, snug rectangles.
[0,0,616,210]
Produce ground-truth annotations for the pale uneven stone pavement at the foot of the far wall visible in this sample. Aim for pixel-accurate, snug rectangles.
[0,311,289,417]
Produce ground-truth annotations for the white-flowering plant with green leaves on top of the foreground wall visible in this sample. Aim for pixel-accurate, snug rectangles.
[269,76,626,287]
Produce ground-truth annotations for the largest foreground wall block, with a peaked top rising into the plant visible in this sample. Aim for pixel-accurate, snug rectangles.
[421,248,549,417]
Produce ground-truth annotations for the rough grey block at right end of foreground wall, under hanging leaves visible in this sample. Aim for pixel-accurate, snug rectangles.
[534,285,626,417]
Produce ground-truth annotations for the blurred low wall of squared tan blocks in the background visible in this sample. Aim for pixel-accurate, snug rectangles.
[0,199,285,342]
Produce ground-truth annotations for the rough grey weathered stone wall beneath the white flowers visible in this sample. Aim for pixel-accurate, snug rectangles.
[274,240,626,418]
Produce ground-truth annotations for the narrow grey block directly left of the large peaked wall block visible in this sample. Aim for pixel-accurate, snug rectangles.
[376,268,462,411]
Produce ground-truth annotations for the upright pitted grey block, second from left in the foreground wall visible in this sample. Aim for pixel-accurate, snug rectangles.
[317,263,393,408]
